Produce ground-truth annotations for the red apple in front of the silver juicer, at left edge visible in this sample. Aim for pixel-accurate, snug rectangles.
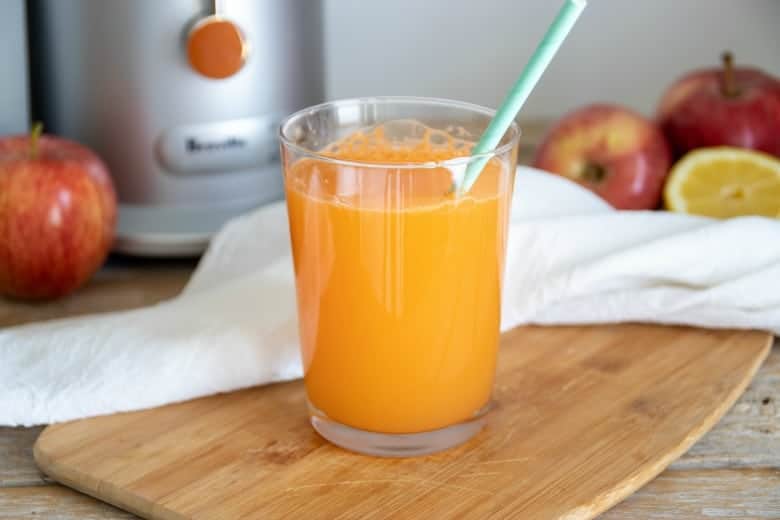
[0,125,116,299]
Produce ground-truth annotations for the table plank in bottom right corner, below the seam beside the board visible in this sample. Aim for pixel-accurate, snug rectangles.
[602,469,780,520]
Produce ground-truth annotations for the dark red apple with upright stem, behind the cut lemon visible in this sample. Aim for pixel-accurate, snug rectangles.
[658,53,780,157]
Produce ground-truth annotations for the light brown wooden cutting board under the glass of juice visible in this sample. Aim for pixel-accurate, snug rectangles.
[35,325,771,520]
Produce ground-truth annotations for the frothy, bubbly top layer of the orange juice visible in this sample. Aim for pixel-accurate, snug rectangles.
[287,120,509,210]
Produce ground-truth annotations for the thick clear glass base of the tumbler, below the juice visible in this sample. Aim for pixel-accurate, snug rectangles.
[309,403,489,457]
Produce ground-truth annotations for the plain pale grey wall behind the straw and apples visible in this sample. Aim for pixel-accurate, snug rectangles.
[325,0,780,119]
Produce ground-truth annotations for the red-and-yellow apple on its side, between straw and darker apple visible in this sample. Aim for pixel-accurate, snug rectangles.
[534,105,671,209]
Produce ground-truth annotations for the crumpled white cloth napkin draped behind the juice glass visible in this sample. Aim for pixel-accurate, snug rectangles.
[0,167,780,425]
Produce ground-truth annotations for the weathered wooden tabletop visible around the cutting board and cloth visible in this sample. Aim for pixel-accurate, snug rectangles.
[0,127,780,520]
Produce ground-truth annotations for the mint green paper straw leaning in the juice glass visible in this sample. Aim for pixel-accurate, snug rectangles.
[458,0,586,194]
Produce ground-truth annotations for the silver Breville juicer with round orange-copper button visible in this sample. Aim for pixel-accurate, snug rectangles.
[30,0,323,256]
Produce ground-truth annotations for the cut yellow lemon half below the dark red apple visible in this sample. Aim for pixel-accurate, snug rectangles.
[664,147,780,218]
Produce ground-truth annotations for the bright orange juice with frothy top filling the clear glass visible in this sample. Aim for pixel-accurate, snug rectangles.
[285,126,514,433]
